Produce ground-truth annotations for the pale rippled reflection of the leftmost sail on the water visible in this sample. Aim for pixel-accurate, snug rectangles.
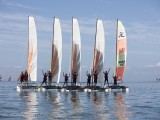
[20,91,38,120]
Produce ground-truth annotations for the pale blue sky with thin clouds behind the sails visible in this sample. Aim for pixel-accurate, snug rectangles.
[0,0,160,82]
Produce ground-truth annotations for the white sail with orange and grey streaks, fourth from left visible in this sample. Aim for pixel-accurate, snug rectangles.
[92,20,105,82]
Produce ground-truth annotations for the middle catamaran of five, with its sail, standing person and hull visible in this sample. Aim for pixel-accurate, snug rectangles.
[63,18,81,90]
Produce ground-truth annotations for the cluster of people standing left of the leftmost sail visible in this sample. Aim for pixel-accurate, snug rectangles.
[18,70,28,86]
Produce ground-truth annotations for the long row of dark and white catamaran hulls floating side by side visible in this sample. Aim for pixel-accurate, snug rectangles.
[17,86,129,92]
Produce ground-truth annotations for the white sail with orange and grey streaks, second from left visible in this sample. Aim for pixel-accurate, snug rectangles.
[51,18,62,83]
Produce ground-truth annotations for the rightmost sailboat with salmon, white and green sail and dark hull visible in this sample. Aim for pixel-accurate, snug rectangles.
[111,20,129,91]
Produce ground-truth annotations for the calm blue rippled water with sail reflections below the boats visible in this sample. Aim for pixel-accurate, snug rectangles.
[0,81,160,120]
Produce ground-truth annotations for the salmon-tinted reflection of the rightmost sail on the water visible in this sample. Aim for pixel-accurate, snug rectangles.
[114,92,129,120]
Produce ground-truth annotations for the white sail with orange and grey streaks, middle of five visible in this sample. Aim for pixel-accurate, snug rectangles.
[71,18,81,82]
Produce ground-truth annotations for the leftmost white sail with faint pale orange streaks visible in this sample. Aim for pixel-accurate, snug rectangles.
[28,16,37,81]
